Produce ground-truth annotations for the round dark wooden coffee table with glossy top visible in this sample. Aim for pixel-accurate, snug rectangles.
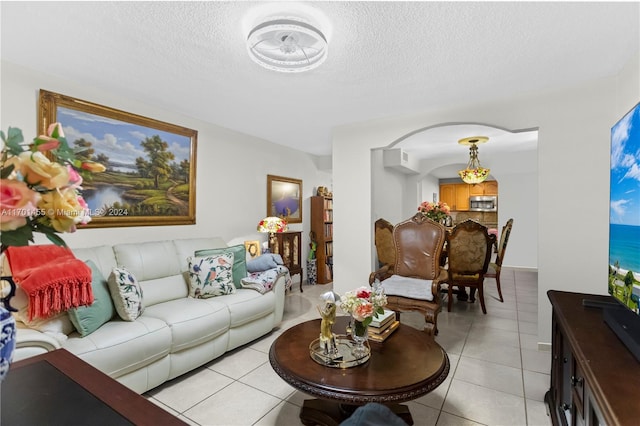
[269,317,449,425]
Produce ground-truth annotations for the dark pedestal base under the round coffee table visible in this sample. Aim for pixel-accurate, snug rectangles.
[300,399,413,426]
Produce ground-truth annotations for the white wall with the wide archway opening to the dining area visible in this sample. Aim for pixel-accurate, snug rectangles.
[333,55,640,343]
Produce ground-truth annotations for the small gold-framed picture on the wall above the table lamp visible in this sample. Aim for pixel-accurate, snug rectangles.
[267,175,302,223]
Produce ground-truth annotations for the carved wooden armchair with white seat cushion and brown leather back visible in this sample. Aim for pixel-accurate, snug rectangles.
[369,213,446,336]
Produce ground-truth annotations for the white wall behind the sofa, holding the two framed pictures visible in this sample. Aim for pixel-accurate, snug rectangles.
[1,62,332,258]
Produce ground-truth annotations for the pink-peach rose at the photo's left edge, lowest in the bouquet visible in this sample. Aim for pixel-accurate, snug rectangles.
[0,179,40,231]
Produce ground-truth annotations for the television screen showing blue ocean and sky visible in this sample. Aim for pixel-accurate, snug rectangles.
[609,104,640,313]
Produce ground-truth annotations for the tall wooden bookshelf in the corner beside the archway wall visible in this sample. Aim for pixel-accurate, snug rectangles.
[311,196,333,284]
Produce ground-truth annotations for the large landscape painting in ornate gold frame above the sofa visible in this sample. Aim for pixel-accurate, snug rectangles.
[38,90,198,228]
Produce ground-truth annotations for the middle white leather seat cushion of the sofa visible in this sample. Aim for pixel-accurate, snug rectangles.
[142,296,230,353]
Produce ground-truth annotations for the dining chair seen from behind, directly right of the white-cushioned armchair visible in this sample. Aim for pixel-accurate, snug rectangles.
[442,219,495,314]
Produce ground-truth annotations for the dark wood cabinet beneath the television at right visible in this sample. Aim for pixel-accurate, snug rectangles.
[545,290,640,426]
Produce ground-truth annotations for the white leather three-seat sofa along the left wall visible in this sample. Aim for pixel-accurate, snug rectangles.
[14,238,285,393]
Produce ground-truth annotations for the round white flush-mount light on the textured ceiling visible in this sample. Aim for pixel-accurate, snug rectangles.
[247,17,328,72]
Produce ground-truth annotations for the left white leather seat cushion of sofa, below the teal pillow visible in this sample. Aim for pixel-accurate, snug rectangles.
[63,316,171,378]
